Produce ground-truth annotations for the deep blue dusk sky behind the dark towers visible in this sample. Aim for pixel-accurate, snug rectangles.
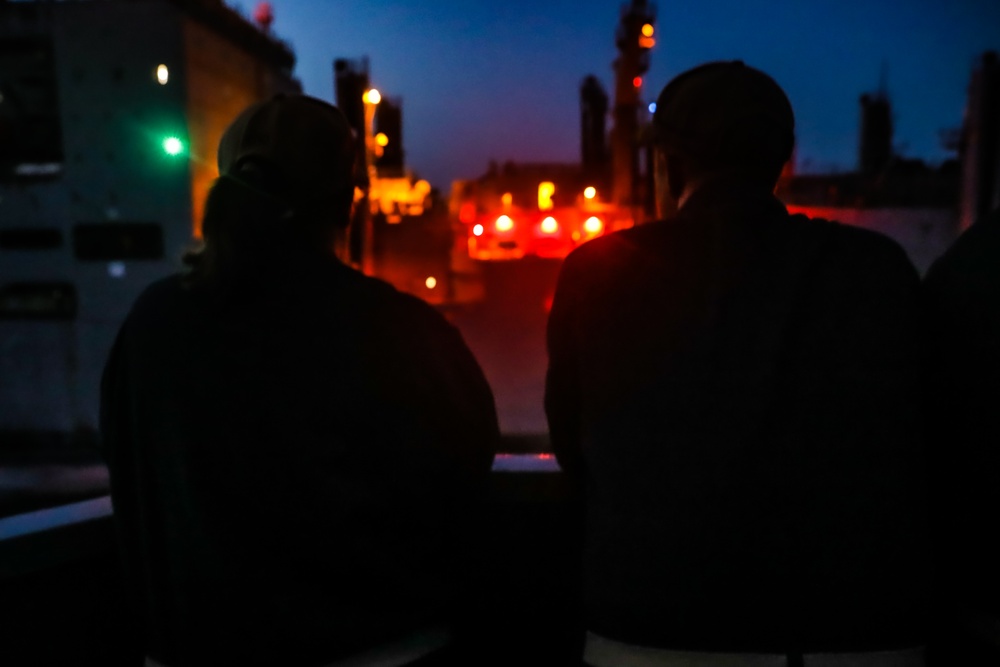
[244,0,1000,190]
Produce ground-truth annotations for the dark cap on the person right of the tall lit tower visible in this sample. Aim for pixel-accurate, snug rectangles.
[643,60,795,170]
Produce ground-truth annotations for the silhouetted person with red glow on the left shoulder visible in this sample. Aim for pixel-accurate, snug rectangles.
[546,62,926,667]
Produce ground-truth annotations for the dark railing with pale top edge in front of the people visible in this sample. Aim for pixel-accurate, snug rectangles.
[0,453,582,667]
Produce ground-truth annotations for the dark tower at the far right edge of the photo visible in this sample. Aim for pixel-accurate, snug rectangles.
[959,51,1000,229]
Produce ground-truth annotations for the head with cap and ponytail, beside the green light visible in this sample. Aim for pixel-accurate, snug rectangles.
[192,95,355,288]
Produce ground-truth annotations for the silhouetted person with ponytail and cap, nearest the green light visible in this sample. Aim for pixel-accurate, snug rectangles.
[101,96,498,667]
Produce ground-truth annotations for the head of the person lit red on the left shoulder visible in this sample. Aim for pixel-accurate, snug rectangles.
[649,60,795,214]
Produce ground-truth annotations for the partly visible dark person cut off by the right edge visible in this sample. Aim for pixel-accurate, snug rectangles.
[924,211,1000,665]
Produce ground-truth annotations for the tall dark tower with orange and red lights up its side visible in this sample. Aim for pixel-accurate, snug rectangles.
[611,0,656,209]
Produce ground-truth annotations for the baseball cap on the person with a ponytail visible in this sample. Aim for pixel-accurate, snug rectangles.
[218,94,354,209]
